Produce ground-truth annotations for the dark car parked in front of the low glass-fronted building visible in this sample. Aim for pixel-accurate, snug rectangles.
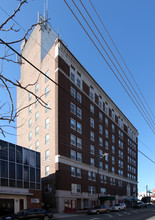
[0,208,53,220]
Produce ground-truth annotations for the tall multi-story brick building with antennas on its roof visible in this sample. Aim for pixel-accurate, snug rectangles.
[17,17,138,212]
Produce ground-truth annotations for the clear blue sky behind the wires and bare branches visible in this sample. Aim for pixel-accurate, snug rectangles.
[0,0,155,191]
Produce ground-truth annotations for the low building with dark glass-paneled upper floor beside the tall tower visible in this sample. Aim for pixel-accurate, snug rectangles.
[0,140,42,216]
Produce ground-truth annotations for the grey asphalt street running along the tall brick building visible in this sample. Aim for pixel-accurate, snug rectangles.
[54,206,155,220]
